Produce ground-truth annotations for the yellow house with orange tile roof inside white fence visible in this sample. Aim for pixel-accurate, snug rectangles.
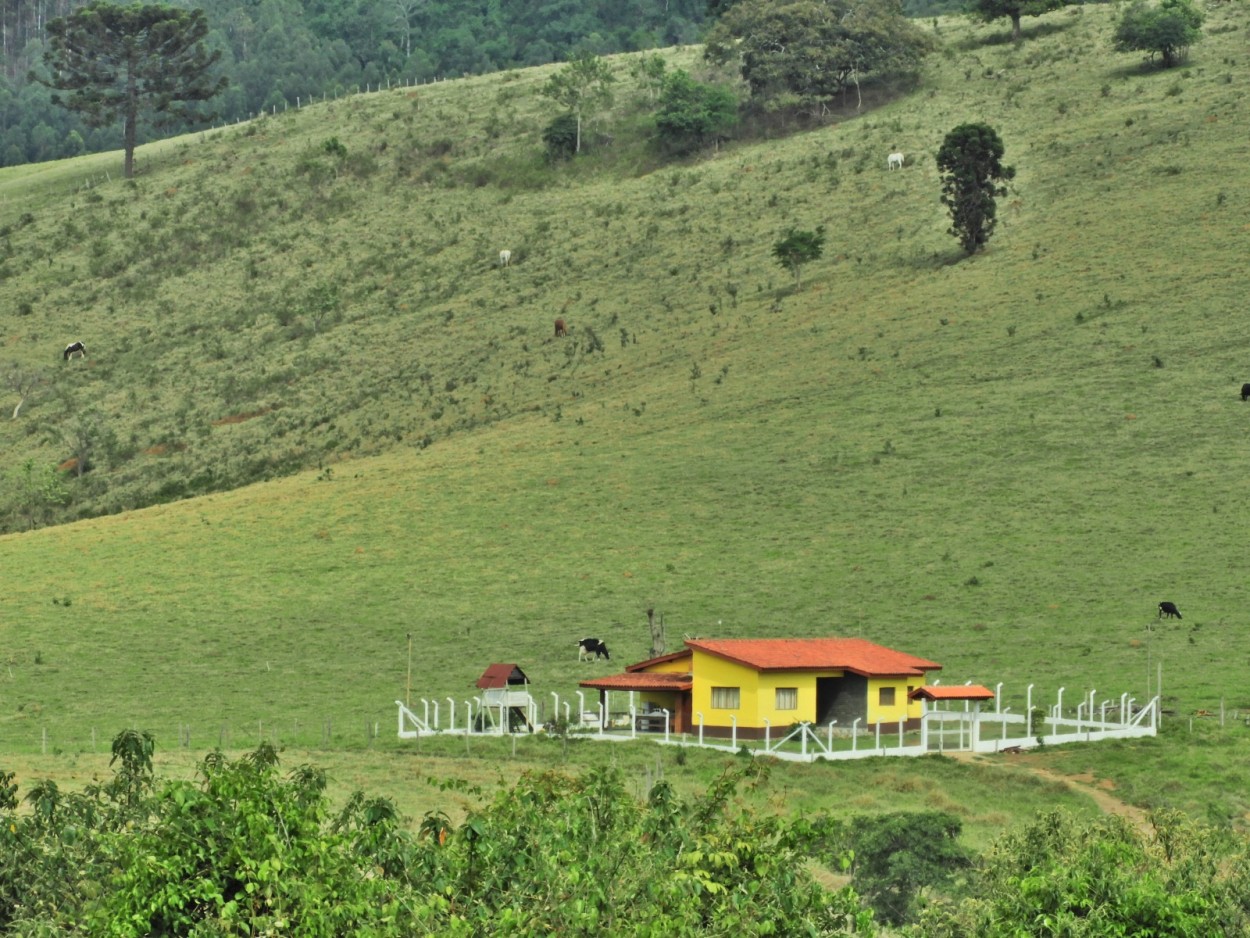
[581,638,941,738]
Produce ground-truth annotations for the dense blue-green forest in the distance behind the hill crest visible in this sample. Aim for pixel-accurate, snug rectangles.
[0,0,960,166]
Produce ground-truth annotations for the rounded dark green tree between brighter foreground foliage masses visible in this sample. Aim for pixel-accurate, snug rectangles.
[850,810,973,925]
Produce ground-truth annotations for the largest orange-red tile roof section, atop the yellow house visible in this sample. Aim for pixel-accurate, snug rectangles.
[686,638,941,677]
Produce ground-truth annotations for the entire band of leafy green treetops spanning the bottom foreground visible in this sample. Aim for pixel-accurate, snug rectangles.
[0,729,1250,938]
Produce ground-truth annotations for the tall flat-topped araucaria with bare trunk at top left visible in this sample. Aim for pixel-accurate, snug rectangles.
[33,0,226,179]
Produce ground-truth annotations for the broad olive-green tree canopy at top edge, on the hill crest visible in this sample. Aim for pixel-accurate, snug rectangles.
[705,0,933,113]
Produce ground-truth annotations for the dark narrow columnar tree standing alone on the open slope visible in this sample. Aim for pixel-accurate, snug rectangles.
[938,124,1015,254]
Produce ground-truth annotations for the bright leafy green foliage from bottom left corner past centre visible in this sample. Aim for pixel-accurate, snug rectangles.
[0,732,871,938]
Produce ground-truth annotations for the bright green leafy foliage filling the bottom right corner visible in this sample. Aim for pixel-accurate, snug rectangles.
[915,812,1250,938]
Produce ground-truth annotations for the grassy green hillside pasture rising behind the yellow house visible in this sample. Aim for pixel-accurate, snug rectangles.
[0,5,1250,830]
